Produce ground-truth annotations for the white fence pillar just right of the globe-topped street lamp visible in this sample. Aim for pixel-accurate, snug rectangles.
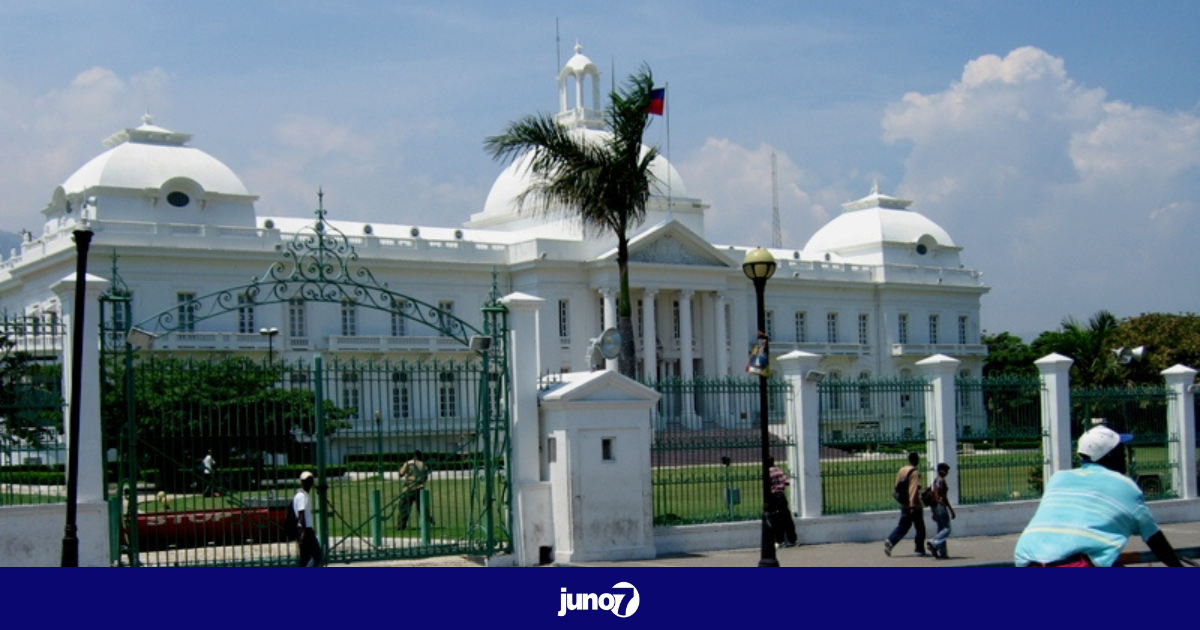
[775,350,824,518]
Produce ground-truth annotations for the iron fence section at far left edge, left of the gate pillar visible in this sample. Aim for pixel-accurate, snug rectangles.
[0,316,66,505]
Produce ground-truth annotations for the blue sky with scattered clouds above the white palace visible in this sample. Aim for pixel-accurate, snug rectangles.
[0,0,1200,334]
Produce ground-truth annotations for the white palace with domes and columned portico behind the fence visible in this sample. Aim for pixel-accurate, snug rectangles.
[0,44,988,388]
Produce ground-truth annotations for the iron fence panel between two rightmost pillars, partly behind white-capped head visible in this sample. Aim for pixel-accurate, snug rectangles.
[1070,385,1176,500]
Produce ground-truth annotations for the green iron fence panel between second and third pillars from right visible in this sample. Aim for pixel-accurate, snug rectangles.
[950,377,1045,504]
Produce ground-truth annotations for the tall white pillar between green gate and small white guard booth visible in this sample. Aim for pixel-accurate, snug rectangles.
[500,293,557,565]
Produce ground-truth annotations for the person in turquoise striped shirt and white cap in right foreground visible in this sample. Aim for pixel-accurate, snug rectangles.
[1013,425,1183,566]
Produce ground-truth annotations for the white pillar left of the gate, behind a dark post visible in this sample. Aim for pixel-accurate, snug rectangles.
[50,274,108,504]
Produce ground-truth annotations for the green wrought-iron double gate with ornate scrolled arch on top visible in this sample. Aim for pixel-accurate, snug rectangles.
[101,198,511,565]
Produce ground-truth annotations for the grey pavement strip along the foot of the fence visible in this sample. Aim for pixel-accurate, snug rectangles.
[559,522,1200,566]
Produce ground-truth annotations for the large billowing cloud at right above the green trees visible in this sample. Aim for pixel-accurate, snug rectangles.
[882,47,1200,332]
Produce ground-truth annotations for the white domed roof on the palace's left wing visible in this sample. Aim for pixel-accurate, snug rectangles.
[62,115,250,196]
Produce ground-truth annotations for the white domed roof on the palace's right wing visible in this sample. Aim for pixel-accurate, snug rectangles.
[804,187,959,256]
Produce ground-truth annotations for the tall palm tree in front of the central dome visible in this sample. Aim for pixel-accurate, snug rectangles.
[484,65,659,378]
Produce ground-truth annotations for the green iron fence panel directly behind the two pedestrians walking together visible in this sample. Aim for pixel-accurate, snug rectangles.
[817,379,932,514]
